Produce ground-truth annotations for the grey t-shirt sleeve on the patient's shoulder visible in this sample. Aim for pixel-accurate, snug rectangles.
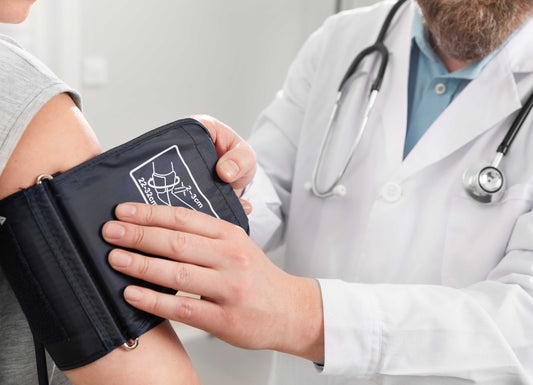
[0,35,81,173]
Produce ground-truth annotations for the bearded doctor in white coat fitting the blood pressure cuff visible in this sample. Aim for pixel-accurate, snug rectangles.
[103,0,533,385]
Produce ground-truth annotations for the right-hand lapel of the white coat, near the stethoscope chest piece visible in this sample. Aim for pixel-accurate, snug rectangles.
[398,15,533,179]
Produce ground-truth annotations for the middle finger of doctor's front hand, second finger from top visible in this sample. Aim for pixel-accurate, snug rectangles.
[102,221,219,267]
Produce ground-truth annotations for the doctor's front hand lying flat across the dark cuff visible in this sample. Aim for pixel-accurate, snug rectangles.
[103,203,324,362]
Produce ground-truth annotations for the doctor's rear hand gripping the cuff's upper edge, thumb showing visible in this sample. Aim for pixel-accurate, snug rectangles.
[190,115,256,214]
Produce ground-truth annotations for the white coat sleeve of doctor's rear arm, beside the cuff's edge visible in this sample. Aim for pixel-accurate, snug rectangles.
[243,19,324,250]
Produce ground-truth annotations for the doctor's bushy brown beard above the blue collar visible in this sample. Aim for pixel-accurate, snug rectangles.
[417,0,533,61]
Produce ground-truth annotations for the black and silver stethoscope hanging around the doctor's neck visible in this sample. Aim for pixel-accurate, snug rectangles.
[305,0,533,203]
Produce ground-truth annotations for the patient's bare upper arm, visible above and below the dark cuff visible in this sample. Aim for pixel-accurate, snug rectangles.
[0,94,199,385]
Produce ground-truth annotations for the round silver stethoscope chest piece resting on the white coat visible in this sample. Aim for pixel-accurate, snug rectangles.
[463,160,505,203]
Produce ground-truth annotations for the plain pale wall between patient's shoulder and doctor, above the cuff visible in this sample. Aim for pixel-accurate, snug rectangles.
[80,0,333,148]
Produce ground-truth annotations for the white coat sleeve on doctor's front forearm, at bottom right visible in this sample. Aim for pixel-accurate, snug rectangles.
[320,212,533,384]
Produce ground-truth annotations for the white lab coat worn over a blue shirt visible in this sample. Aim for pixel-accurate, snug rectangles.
[247,1,533,385]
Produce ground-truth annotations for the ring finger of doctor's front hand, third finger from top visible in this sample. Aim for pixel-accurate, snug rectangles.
[108,249,224,299]
